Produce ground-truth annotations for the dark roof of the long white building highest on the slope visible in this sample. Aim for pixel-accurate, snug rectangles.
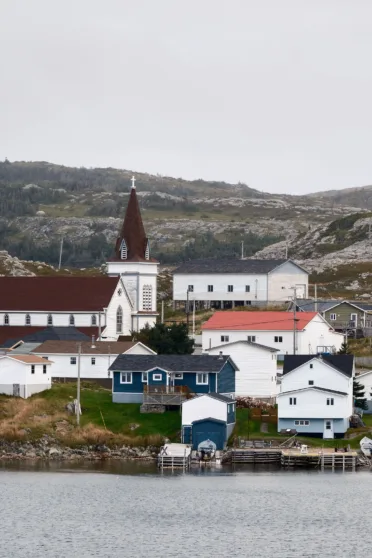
[173,258,288,275]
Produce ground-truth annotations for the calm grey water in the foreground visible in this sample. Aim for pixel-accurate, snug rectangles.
[0,464,372,558]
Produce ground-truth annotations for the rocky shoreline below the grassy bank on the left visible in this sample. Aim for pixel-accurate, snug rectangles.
[0,435,159,461]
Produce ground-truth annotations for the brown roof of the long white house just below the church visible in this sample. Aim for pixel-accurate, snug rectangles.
[33,340,136,355]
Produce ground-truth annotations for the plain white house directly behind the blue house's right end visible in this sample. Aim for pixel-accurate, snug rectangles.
[206,341,278,399]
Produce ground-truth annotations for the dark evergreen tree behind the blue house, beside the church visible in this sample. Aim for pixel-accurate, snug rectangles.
[133,323,194,355]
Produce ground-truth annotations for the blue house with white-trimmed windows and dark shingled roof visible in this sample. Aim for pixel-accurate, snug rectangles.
[110,354,238,406]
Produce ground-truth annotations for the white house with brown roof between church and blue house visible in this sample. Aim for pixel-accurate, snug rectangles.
[33,340,156,387]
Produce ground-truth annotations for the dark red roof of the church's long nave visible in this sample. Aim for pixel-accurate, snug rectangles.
[0,277,119,313]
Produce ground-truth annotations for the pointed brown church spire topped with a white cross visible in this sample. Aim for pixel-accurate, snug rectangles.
[115,176,150,262]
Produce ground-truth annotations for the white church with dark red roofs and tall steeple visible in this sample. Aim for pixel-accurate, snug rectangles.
[0,178,158,346]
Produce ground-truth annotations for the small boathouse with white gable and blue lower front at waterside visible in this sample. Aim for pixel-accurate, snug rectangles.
[182,393,236,450]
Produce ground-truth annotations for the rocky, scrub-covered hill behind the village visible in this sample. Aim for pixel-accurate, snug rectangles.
[0,161,372,267]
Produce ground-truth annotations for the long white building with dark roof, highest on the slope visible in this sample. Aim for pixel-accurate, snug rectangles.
[173,259,309,308]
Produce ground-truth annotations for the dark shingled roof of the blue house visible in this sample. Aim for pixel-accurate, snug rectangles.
[110,354,237,372]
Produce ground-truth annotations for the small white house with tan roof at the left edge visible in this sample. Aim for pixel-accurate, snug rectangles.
[0,354,52,398]
